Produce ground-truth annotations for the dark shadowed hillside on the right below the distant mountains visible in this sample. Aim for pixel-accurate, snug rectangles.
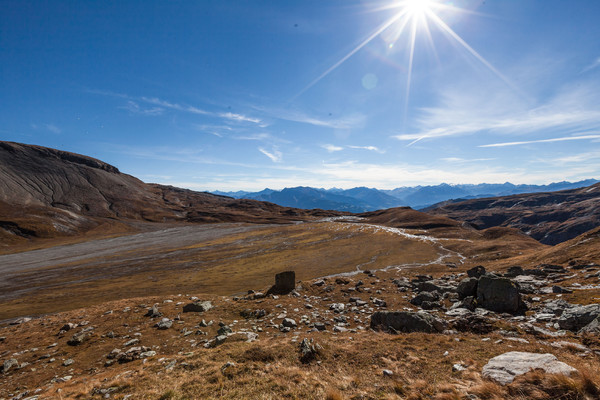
[426,184,600,245]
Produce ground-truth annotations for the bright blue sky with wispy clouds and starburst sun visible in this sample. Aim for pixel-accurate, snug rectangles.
[0,0,600,191]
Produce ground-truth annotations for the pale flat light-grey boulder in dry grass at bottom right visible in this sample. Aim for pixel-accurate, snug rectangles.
[481,351,577,385]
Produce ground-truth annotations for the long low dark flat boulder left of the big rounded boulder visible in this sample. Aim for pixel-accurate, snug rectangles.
[371,311,447,333]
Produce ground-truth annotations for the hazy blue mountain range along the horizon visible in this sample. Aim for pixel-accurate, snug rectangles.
[213,179,599,213]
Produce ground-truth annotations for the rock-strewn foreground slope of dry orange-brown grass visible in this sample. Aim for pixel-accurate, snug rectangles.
[0,263,600,399]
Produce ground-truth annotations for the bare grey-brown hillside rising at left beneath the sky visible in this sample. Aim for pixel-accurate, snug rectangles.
[0,142,339,242]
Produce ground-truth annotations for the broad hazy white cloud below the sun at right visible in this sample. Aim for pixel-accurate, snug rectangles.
[394,83,600,145]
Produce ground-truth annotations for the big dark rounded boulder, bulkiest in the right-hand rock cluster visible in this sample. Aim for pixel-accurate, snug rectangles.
[477,274,523,313]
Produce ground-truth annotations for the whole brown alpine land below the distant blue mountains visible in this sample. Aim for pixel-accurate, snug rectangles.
[0,143,600,400]
